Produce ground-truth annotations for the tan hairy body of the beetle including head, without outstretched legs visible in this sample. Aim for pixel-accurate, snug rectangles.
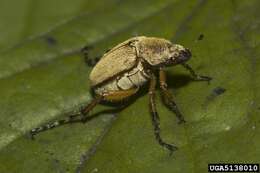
[90,36,189,101]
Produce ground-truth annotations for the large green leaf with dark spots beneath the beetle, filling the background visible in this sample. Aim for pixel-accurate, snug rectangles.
[0,0,260,173]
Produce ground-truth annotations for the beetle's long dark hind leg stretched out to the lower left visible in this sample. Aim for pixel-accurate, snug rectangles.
[30,96,103,138]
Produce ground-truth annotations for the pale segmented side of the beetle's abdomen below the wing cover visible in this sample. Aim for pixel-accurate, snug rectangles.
[95,62,149,94]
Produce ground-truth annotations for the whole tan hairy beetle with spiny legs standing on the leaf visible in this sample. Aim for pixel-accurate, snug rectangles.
[30,36,211,152]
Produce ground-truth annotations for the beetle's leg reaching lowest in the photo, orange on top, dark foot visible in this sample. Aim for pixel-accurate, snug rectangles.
[149,74,177,154]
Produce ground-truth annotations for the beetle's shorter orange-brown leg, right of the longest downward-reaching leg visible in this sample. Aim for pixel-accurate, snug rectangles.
[159,69,185,123]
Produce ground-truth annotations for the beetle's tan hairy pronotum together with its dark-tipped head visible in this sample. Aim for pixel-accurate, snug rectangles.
[138,37,191,67]
